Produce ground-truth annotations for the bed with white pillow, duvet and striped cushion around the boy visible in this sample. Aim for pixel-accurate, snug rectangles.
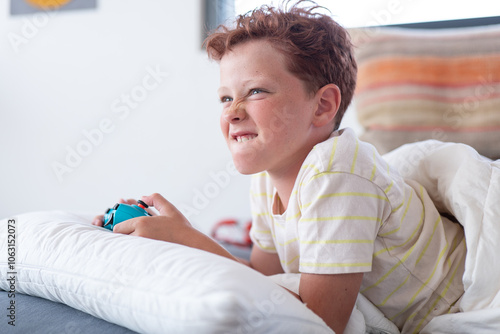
[0,20,500,334]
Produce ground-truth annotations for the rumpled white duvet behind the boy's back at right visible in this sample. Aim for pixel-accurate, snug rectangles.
[385,141,500,334]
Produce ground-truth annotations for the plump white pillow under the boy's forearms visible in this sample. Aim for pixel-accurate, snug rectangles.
[0,212,338,334]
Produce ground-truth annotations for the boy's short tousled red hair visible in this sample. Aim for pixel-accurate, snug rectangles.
[204,1,357,130]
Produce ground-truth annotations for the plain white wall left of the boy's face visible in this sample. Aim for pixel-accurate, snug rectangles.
[0,0,250,230]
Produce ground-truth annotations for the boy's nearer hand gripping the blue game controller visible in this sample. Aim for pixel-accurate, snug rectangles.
[113,194,194,244]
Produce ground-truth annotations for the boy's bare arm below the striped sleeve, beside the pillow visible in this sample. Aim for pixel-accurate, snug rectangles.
[299,273,363,334]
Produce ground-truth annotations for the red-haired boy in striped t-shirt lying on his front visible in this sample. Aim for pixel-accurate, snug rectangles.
[93,1,466,333]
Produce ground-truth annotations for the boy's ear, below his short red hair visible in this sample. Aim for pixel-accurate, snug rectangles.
[313,84,341,127]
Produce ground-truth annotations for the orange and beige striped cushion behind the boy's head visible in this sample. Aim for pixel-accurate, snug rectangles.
[351,25,500,158]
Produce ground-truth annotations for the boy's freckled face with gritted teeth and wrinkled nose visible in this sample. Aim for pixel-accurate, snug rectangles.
[218,40,316,175]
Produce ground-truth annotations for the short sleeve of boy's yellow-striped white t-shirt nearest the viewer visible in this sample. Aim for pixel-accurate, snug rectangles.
[298,172,391,274]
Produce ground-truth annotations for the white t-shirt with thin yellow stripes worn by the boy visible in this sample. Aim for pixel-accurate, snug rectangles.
[251,129,466,332]
